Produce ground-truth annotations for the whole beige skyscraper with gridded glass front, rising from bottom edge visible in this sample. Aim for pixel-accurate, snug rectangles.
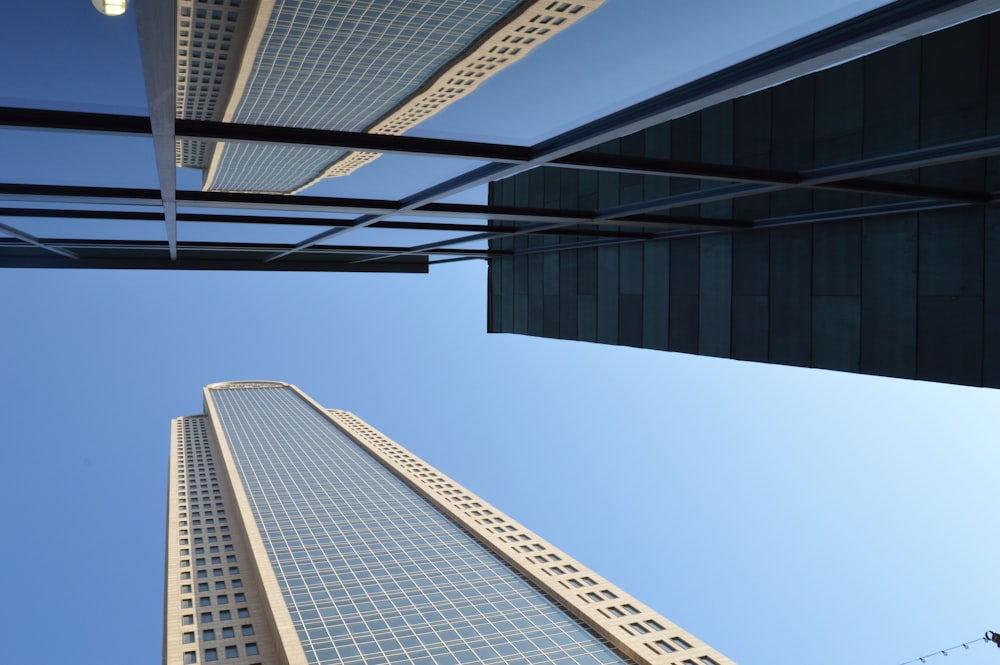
[163,381,732,665]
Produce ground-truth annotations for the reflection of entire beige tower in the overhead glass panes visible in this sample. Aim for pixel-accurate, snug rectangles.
[177,0,603,193]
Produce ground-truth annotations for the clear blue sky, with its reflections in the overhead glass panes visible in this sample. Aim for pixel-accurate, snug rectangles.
[0,0,1000,665]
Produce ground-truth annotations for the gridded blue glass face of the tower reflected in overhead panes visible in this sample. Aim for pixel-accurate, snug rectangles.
[209,0,519,191]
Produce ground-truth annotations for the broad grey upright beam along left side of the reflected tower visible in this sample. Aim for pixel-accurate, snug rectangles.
[134,0,177,260]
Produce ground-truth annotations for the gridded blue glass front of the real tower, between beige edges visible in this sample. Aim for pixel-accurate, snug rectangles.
[208,387,630,665]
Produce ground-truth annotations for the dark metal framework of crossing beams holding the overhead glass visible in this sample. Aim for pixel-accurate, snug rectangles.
[0,0,1000,272]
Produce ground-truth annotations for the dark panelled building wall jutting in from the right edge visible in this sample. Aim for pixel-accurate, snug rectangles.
[488,15,1000,387]
